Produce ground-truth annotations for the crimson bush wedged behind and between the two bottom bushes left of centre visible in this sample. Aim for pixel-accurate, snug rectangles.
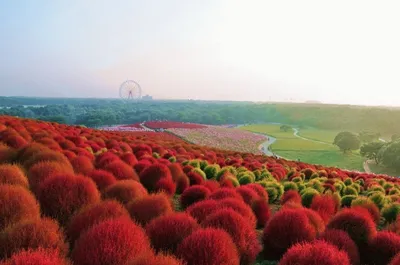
[146,213,199,254]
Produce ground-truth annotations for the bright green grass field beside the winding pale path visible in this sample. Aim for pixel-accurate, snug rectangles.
[241,124,364,171]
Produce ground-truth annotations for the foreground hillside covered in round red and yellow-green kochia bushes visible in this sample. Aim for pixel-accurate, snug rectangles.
[0,116,400,265]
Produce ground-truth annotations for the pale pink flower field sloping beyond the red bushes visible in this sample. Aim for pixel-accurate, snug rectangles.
[168,126,268,154]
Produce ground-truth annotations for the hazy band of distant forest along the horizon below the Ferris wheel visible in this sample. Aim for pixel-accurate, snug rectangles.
[0,97,400,136]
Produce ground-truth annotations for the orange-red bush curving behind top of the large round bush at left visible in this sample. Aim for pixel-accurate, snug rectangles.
[28,161,74,193]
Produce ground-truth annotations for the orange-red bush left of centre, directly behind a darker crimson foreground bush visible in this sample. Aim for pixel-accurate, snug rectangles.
[127,193,173,225]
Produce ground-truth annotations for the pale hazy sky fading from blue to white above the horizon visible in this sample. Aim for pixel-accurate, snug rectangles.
[0,0,400,105]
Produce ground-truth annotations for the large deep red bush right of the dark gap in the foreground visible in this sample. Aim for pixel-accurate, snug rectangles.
[262,209,316,260]
